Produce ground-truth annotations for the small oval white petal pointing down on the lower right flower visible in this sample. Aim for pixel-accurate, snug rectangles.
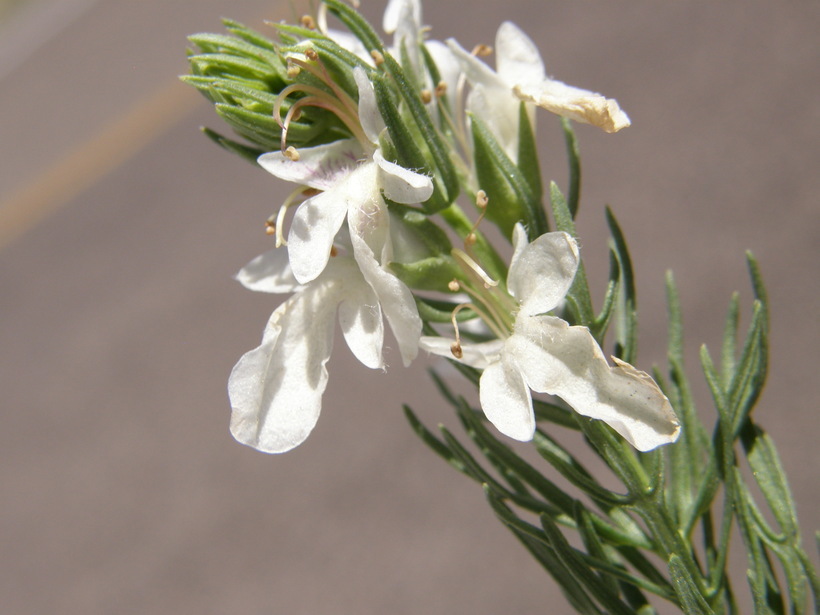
[479,353,535,442]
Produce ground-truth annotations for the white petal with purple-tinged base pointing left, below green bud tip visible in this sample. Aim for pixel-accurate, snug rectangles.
[257,139,364,190]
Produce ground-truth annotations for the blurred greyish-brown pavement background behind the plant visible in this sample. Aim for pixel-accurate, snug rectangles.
[0,0,820,615]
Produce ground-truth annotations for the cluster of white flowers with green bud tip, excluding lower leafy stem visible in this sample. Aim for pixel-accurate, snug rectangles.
[189,0,678,453]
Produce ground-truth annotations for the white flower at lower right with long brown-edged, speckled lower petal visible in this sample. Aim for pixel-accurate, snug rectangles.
[420,224,680,451]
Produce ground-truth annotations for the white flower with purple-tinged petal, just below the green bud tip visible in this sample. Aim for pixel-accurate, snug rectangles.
[259,68,433,284]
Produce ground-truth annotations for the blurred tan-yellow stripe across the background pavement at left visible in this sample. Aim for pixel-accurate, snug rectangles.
[0,81,204,249]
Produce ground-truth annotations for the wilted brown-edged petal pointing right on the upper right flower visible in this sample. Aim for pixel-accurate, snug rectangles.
[513,79,631,132]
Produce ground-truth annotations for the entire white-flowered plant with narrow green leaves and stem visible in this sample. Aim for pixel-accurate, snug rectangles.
[183,0,819,613]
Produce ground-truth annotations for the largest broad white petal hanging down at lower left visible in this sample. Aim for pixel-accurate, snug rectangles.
[228,283,336,453]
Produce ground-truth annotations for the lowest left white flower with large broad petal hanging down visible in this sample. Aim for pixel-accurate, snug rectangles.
[228,233,421,453]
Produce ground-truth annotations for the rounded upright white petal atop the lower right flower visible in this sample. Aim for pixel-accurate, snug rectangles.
[507,224,579,316]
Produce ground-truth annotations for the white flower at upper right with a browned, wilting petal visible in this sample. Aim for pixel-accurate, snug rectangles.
[448,21,630,147]
